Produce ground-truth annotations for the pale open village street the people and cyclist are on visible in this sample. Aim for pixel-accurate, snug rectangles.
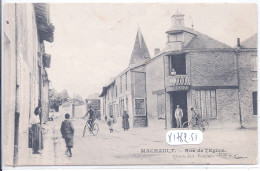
[23,113,257,166]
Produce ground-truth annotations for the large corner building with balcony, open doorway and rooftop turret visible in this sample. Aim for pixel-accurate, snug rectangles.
[146,12,257,128]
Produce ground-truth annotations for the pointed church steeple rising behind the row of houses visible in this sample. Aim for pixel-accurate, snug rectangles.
[129,28,151,65]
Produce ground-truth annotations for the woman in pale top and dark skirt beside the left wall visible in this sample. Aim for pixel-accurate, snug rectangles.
[30,107,43,154]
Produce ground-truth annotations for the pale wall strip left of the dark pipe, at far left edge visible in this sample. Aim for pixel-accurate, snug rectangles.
[2,4,16,166]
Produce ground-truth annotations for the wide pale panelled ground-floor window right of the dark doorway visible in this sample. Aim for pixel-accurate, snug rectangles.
[195,90,217,118]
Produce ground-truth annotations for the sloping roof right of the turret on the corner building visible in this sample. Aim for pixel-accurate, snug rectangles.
[185,31,231,49]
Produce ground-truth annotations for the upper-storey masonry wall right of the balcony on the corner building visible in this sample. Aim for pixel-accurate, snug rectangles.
[186,50,238,86]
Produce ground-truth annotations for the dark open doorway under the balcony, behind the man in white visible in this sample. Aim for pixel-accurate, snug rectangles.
[171,91,188,128]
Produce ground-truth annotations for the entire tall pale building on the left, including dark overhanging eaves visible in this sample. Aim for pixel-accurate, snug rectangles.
[2,3,54,165]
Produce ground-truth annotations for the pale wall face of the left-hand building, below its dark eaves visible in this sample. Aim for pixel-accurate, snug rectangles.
[4,3,47,165]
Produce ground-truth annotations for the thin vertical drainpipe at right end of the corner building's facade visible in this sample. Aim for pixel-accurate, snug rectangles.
[235,38,245,129]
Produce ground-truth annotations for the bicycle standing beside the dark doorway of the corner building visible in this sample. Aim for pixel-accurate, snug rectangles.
[182,117,209,132]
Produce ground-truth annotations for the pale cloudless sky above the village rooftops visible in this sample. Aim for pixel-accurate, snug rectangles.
[45,3,257,98]
